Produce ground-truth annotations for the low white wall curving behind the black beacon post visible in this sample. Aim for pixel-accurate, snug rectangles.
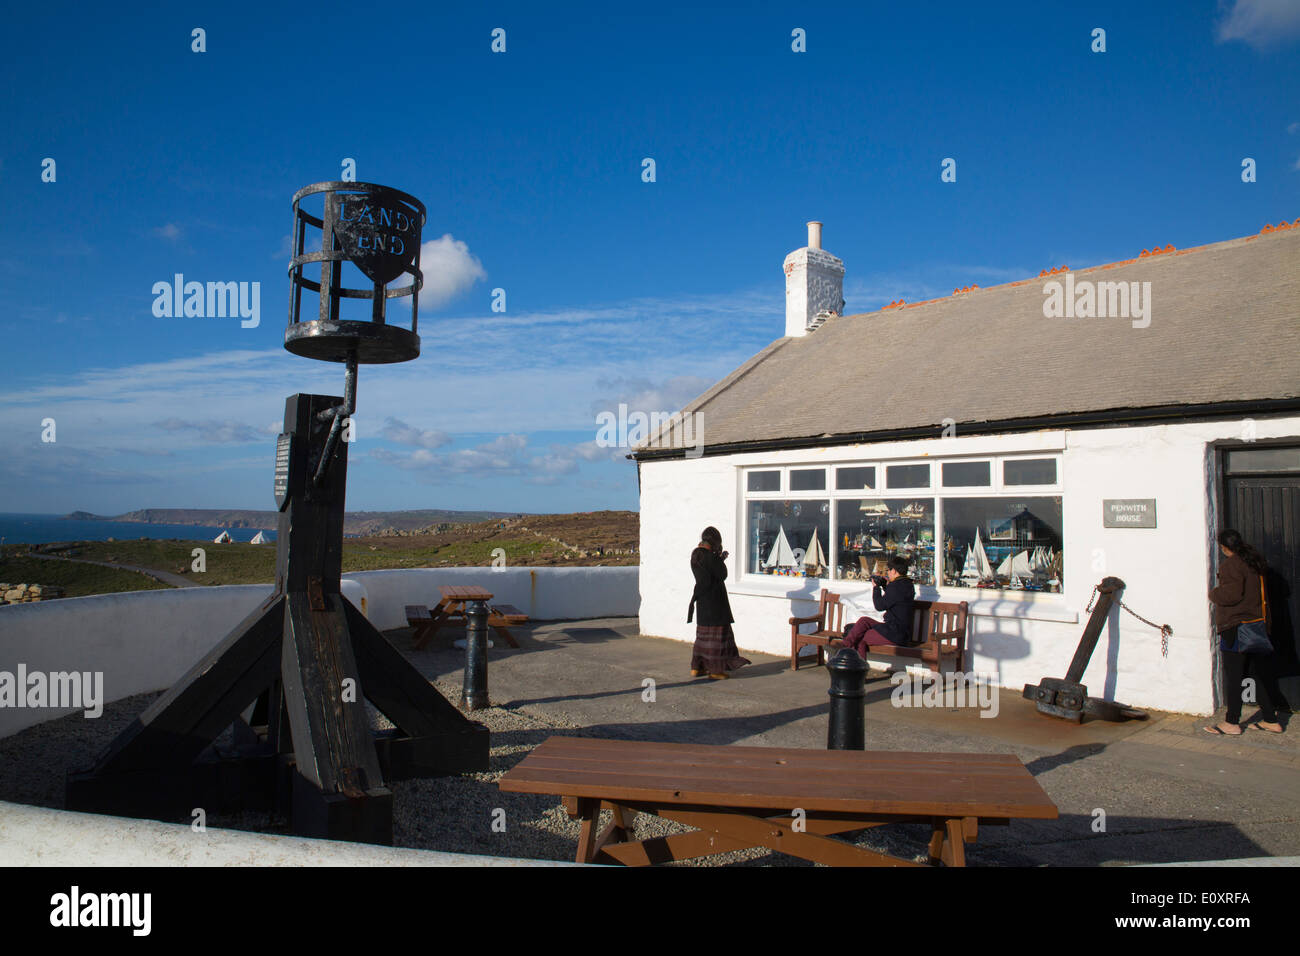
[0,567,640,737]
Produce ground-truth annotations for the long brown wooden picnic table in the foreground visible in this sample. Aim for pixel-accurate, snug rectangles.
[498,736,1057,866]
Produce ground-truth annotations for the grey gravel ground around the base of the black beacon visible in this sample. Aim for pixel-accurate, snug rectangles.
[0,680,941,866]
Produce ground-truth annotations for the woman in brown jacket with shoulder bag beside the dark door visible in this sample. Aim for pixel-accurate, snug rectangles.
[1203,528,1282,737]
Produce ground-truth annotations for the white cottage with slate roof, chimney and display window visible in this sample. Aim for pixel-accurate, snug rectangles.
[633,220,1300,714]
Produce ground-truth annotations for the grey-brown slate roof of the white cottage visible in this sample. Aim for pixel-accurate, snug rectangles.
[636,220,1300,458]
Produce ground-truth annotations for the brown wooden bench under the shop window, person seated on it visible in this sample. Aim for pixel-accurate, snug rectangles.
[790,591,969,672]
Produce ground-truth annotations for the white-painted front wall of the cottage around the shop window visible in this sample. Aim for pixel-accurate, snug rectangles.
[641,416,1300,714]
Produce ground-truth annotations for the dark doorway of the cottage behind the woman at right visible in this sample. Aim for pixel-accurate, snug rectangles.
[1221,445,1300,711]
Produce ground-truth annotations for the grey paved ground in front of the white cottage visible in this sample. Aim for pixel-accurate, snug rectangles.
[410,618,1300,865]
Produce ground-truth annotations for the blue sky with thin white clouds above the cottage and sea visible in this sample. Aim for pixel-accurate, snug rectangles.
[0,0,1300,514]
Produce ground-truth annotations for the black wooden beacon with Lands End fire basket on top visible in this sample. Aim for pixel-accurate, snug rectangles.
[66,183,489,844]
